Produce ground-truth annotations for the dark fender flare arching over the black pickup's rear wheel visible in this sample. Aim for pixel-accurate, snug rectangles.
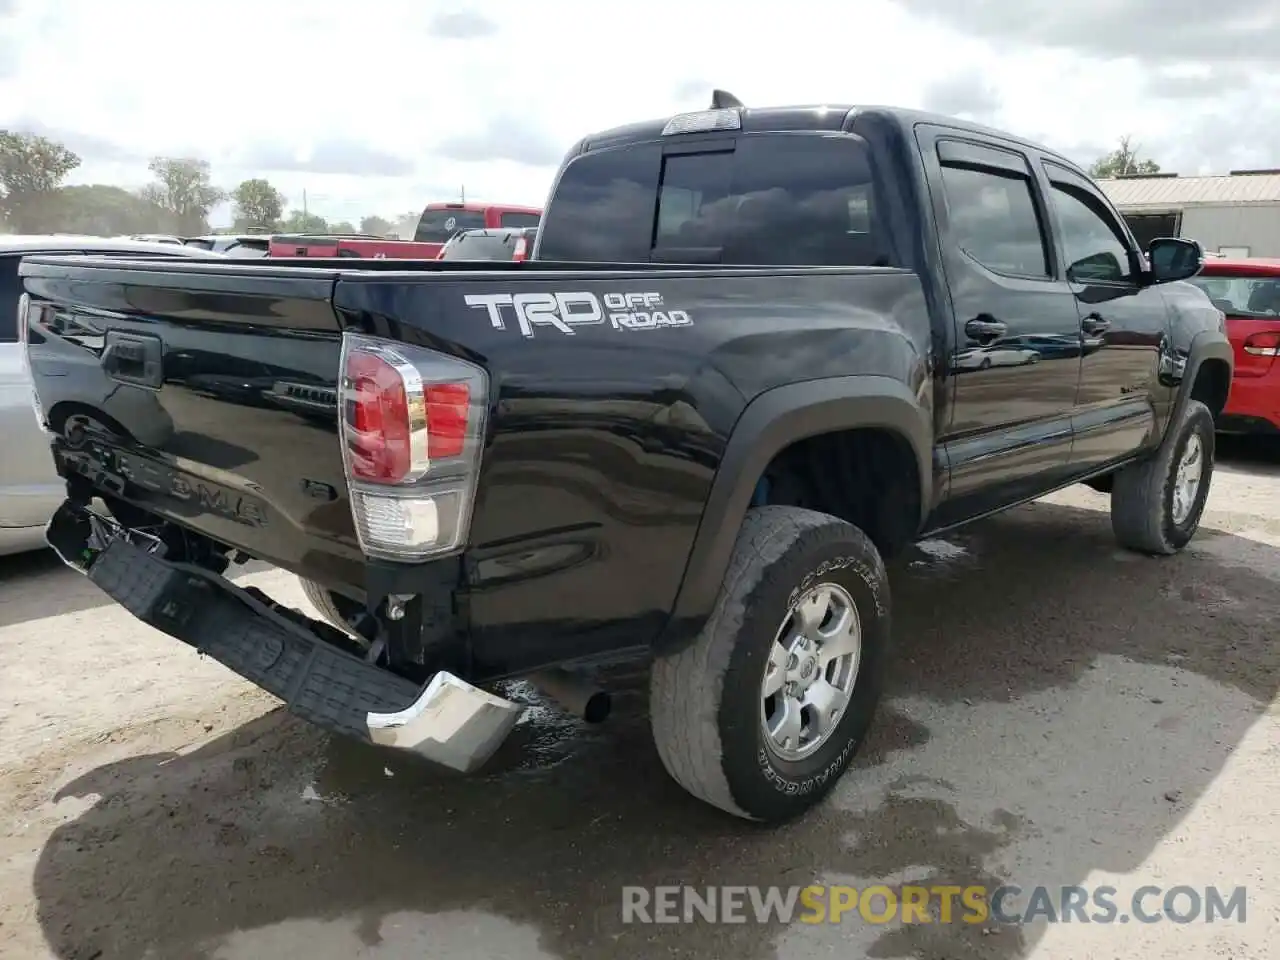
[657,376,933,652]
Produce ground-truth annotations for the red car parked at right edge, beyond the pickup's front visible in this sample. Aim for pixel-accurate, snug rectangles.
[1192,256,1280,434]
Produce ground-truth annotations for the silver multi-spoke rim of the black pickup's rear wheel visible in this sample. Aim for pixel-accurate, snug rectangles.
[760,584,863,760]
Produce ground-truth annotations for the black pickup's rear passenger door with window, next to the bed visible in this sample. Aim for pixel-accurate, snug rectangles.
[922,131,1080,525]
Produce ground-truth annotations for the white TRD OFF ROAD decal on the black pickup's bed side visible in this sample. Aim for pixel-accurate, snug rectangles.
[465,291,694,337]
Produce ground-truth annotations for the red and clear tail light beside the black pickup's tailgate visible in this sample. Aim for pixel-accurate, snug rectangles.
[338,334,489,562]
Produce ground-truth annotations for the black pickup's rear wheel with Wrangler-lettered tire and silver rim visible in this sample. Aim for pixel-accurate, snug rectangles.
[649,507,890,823]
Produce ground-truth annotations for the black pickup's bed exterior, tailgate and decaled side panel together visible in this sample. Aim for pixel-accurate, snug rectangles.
[22,257,929,676]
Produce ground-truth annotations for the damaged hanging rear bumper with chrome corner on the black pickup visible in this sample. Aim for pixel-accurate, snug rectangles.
[46,500,524,773]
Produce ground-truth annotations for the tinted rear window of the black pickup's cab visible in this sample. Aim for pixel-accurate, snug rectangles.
[539,133,890,266]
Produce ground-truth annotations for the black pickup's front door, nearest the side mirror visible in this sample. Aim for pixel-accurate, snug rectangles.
[1044,160,1169,472]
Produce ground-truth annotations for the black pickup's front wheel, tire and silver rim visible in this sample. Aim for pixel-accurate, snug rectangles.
[1111,401,1215,556]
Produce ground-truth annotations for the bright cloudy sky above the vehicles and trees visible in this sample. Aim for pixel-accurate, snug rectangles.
[0,0,1280,220]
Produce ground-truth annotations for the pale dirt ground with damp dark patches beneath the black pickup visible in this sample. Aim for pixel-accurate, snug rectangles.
[0,445,1280,960]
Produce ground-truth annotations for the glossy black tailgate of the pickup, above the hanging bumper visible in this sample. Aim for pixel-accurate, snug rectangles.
[22,257,361,582]
